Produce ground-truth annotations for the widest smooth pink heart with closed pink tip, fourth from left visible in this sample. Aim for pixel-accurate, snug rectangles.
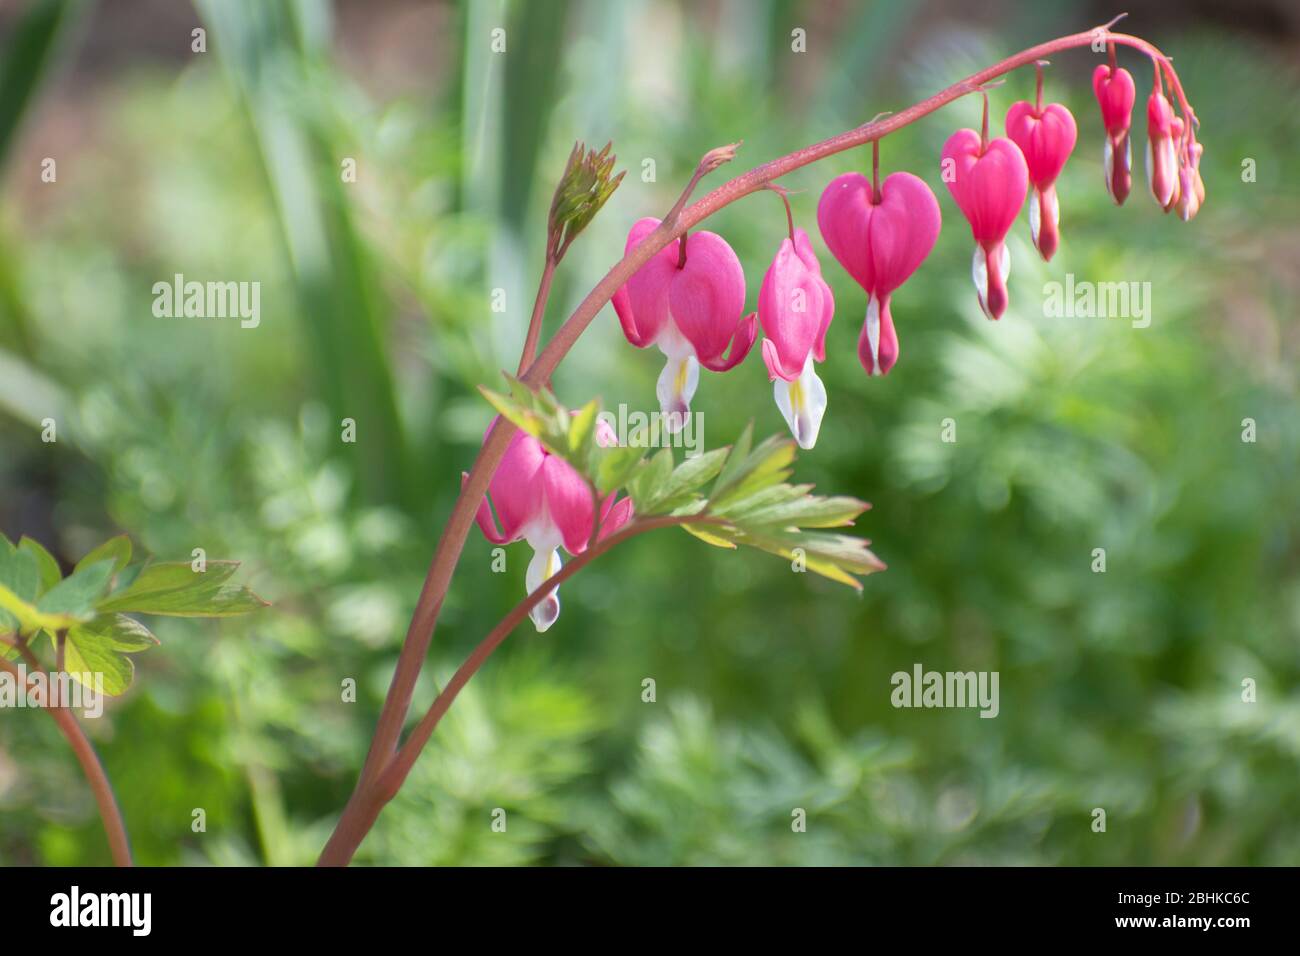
[816,167,941,375]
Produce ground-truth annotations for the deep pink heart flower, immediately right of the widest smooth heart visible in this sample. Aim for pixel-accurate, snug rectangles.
[943,123,1030,319]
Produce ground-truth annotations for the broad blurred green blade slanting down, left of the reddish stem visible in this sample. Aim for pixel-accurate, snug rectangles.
[198,0,413,505]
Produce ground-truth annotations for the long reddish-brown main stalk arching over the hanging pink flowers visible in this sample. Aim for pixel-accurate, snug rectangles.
[320,21,1195,865]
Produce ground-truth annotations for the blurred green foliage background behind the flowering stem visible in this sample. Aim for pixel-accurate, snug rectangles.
[0,0,1300,865]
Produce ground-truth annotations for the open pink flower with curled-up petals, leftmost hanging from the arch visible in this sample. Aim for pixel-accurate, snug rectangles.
[614,219,757,432]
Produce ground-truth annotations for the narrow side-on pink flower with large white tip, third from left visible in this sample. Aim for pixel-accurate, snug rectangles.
[758,229,835,449]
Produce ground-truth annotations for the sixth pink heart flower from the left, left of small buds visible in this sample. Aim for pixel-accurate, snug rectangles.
[1006,65,1079,261]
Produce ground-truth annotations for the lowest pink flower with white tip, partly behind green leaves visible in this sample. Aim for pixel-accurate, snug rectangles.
[473,419,632,631]
